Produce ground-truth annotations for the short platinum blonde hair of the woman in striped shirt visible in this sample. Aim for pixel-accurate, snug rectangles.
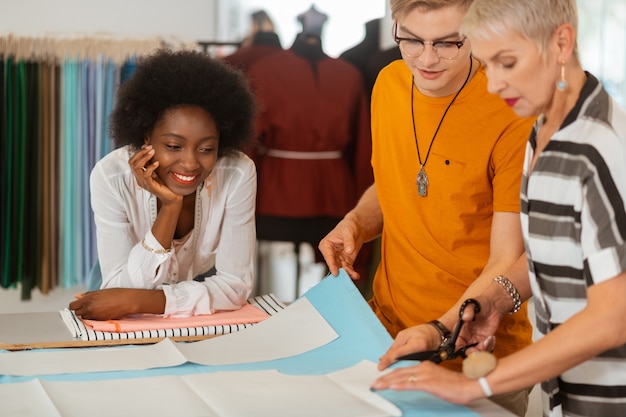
[461,0,578,54]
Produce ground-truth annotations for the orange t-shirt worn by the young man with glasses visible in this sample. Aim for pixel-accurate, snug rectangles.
[370,61,533,368]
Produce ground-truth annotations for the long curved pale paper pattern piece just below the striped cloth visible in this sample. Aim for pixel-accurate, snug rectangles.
[0,298,338,376]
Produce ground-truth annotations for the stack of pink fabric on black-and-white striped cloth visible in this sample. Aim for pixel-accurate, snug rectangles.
[59,294,285,340]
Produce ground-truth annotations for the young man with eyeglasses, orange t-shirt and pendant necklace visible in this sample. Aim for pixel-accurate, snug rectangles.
[319,0,533,416]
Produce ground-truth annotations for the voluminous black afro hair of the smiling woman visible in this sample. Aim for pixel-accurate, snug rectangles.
[111,50,255,156]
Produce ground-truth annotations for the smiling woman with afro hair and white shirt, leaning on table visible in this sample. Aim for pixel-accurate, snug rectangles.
[70,49,256,320]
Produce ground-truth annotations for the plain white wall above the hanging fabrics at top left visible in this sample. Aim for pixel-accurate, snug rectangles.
[0,0,218,42]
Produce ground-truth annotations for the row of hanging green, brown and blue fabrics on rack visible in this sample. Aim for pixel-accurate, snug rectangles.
[0,34,196,299]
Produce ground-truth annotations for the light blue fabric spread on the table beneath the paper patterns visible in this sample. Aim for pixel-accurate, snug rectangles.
[0,270,477,417]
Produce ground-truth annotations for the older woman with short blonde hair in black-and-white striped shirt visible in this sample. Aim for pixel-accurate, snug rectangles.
[373,0,626,417]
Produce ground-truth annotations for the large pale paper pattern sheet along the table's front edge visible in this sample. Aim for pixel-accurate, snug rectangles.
[0,361,402,417]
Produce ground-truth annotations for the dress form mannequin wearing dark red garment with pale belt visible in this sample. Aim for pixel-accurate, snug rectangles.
[244,6,372,295]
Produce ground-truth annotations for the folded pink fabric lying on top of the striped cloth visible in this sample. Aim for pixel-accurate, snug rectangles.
[83,304,269,333]
